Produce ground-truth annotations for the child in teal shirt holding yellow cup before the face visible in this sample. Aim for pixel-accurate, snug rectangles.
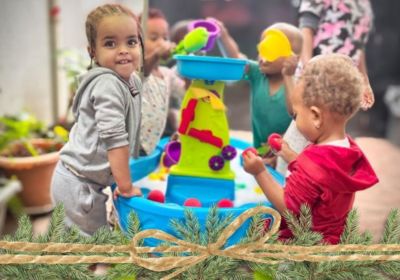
[216,21,302,151]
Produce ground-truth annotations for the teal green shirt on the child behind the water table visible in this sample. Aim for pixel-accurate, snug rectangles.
[245,61,292,148]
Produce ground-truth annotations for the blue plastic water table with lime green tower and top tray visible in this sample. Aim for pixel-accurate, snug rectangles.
[114,20,284,246]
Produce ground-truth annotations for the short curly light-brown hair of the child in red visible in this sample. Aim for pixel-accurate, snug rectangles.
[301,54,364,116]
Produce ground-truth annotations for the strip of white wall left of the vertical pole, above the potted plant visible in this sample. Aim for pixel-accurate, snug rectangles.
[0,0,51,122]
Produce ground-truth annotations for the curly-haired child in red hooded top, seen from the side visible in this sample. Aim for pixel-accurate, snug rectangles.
[244,54,378,244]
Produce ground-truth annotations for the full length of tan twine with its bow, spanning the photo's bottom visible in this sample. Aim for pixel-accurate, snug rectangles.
[0,203,400,279]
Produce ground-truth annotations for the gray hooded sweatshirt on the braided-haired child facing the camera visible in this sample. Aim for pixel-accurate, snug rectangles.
[60,67,142,186]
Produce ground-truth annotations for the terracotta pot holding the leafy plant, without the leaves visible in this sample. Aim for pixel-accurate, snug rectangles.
[0,139,62,214]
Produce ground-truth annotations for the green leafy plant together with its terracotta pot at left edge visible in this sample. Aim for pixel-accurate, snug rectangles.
[0,114,68,214]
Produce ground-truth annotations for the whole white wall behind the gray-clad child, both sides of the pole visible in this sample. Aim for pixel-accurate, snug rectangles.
[0,0,143,123]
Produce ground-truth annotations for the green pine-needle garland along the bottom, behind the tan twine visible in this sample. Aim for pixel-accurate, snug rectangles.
[0,200,400,280]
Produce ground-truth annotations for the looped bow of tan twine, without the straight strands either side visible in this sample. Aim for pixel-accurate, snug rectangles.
[131,206,281,279]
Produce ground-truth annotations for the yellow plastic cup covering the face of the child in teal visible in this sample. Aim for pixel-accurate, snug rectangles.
[257,29,292,62]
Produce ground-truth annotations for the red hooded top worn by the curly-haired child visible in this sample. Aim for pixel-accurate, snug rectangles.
[280,137,378,244]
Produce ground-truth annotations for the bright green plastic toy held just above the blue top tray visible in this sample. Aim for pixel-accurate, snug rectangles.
[172,27,210,54]
